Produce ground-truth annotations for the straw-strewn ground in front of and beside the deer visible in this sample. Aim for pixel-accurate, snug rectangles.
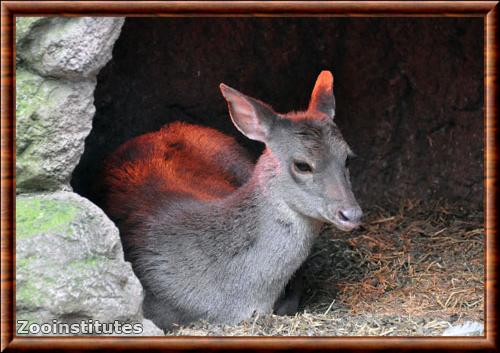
[167,200,484,336]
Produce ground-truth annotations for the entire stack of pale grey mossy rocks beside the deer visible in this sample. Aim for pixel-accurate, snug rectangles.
[16,17,162,335]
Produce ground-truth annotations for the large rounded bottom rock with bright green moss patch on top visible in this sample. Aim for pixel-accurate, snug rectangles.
[16,191,163,335]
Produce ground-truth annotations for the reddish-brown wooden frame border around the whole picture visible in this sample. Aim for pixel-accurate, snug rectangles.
[0,1,499,351]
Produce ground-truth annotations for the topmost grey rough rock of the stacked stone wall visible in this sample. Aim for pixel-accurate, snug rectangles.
[18,17,124,80]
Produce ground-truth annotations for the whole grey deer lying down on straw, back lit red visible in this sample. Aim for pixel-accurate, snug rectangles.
[99,71,362,329]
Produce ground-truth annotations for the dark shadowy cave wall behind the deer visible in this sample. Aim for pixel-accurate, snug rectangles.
[72,17,484,209]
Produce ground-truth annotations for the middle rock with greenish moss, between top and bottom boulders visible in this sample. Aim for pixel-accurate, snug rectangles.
[16,68,95,192]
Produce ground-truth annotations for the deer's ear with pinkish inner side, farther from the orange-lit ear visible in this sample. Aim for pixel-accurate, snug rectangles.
[219,83,275,142]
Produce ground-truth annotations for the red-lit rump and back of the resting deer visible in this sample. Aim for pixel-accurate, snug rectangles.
[102,122,252,226]
